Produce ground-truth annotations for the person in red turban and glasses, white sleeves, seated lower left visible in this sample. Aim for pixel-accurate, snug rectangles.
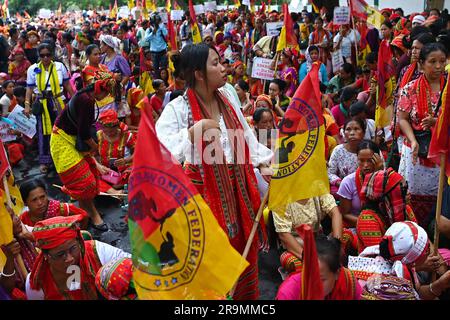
[26,215,131,300]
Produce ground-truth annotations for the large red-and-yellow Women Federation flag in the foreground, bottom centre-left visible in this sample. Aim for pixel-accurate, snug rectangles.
[128,103,249,300]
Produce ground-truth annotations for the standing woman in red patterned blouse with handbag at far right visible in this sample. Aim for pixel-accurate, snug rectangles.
[397,43,447,225]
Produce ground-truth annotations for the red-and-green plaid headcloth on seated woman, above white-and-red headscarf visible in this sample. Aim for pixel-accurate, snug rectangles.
[359,168,406,226]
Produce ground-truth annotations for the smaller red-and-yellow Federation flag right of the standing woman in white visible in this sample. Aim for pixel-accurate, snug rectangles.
[269,63,330,214]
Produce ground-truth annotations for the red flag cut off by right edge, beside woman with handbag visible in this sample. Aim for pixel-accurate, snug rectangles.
[428,79,450,177]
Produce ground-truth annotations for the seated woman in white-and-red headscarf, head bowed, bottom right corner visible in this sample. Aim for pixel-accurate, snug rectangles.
[349,221,450,300]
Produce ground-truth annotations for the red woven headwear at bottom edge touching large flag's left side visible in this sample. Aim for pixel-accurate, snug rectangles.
[95,258,133,300]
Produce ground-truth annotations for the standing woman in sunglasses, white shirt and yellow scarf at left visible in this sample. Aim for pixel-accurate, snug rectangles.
[24,43,74,173]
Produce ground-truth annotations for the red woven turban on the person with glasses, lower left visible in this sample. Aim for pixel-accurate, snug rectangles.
[33,214,84,250]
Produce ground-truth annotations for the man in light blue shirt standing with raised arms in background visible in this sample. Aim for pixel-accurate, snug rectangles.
[145,15,168,78]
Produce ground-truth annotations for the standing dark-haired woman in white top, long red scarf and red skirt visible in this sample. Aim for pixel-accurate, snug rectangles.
[156,43,272,300]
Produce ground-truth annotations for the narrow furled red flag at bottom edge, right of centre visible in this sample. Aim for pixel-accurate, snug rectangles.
[296,224,324,300]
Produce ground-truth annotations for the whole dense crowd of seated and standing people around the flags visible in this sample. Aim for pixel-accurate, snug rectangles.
[0,6,450,300]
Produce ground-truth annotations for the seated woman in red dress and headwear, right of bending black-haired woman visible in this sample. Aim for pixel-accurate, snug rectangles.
[97,110,136,193]
